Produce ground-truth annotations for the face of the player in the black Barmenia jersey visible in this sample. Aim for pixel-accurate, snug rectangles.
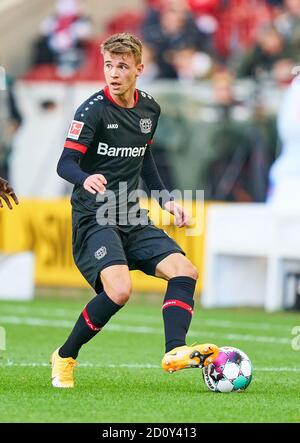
[104,51,143,96]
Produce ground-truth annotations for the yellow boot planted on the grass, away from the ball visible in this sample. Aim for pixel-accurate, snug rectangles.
[50,349,77,388]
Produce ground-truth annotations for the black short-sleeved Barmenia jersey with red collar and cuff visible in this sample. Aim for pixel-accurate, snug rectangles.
[65,87,160,221]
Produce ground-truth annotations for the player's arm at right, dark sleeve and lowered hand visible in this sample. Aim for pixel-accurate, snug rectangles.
[141,146,189,228]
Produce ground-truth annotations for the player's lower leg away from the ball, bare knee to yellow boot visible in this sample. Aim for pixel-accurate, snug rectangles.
[50,265,131,388]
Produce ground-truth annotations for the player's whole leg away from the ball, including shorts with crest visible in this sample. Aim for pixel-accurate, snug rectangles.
[50,228,131,388]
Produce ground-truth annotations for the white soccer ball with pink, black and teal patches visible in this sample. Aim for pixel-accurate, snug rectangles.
[202,346,253,392]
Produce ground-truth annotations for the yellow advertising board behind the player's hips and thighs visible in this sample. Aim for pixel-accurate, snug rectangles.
[0,198,205,292]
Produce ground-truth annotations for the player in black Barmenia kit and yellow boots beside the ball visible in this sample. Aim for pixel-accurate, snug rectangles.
[51,33,218,388]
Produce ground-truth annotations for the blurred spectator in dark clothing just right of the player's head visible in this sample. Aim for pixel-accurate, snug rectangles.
[143,0,208,78]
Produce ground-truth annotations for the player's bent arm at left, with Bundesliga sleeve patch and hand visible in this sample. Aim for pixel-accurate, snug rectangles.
[57,108,107,194]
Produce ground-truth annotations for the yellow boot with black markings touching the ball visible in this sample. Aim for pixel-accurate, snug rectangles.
[161,343,219,373]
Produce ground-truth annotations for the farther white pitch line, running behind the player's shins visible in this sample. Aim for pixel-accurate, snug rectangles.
[0,316,291,345]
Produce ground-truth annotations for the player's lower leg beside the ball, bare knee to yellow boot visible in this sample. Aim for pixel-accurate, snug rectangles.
[155,253,219,373]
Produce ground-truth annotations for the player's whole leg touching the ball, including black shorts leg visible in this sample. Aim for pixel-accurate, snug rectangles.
[126,223,218,372]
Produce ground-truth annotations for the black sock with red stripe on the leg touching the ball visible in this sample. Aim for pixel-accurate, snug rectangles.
[163,277,196,352]
